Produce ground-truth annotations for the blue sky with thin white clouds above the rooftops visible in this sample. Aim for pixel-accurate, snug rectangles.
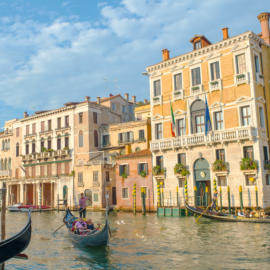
[0,0,270,127]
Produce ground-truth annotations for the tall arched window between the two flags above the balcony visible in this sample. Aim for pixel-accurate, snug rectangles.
[190,99,205,134]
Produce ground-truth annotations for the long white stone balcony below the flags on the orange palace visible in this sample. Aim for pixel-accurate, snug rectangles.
[150,127,257,151]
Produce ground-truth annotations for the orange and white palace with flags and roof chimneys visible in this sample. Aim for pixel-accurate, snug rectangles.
[147,13,270,208]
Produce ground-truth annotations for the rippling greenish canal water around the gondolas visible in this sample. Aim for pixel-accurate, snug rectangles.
[1,212,270,270]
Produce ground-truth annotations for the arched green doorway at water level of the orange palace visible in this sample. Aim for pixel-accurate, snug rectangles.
[194,158,211,206]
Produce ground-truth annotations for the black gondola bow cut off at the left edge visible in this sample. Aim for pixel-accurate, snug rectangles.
[0,212,31,264]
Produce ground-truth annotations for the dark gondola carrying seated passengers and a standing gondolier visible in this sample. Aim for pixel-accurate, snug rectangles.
[63,209,110,247]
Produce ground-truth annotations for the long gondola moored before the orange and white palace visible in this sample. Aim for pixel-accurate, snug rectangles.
[185,204,270,223]
